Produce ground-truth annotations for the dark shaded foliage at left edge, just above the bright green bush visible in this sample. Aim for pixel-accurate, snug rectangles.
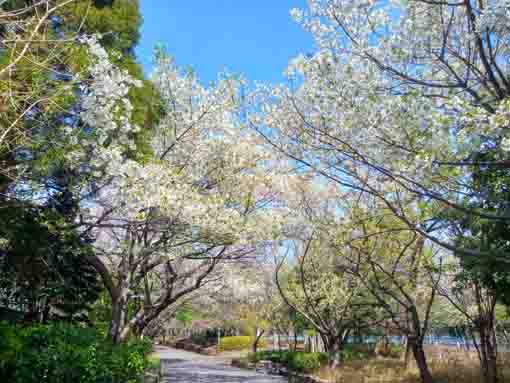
[0,204,101,319]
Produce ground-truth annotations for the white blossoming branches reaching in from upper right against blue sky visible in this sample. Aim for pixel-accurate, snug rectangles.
[250,0,510,260]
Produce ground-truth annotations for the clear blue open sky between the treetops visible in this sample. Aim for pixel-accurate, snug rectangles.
[137,0,313,83]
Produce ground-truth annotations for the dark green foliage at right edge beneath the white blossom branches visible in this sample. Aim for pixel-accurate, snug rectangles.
[438,148,510,305]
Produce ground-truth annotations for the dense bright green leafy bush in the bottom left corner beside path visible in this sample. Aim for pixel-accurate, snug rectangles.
[0,324,152,383]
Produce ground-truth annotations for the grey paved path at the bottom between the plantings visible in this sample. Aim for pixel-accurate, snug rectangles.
[156,346,286,383]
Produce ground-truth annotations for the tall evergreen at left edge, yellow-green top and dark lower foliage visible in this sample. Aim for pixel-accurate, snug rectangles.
[0,0,159,320]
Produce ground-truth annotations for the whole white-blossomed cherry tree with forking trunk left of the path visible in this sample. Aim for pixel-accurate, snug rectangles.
[76,48,279,342]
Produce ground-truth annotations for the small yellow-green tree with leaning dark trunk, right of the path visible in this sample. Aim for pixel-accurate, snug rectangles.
[337,209,442,382]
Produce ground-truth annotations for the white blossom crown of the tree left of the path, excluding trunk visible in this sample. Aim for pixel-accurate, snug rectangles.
[83,45,281,260]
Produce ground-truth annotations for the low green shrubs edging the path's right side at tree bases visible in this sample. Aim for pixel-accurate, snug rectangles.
[248,351,328,372]
